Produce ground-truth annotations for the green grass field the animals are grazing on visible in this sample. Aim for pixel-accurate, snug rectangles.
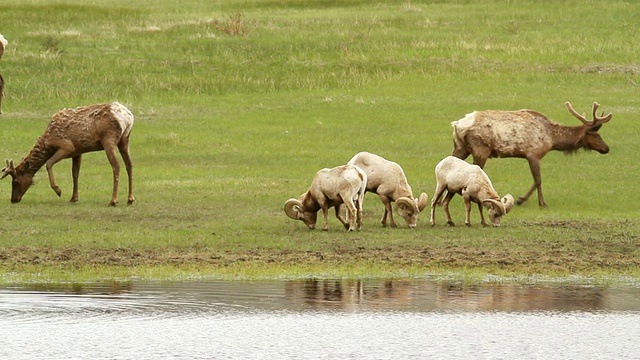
[0,0,640,283]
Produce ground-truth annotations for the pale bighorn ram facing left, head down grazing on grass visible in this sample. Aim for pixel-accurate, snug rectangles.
[284,165,367,231]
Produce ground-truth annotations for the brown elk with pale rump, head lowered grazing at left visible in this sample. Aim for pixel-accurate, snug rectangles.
[0,102,135,206]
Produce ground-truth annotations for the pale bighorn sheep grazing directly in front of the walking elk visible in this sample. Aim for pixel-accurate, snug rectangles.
[431,156,514,226]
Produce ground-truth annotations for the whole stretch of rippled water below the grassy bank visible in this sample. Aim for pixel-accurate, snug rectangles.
[0,280,640,359]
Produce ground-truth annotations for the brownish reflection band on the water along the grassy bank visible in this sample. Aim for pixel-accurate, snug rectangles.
[0,279,640,315]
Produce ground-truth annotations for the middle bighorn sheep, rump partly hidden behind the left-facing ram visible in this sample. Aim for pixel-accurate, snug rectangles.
[348,152,429,228]
